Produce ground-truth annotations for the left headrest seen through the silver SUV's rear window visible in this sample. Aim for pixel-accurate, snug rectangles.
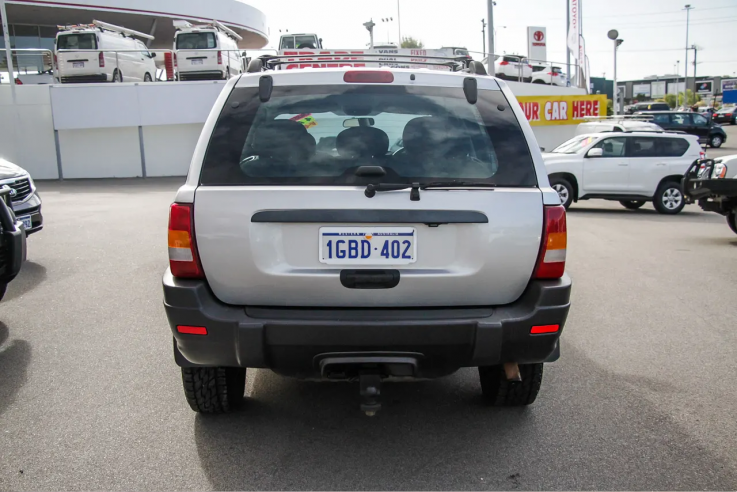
[252,120,316,160]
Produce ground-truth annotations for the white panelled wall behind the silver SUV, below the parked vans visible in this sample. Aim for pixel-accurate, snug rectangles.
[0,81,584,179]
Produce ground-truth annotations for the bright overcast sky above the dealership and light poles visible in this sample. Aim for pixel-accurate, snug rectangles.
[245,0,737,80]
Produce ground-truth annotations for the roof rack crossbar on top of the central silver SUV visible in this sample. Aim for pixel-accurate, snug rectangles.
[260,53,468,72]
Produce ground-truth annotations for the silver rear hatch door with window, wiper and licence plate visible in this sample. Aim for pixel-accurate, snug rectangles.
[194,72,543,307]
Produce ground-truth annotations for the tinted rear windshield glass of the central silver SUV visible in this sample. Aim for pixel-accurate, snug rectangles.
[201,85,537,186]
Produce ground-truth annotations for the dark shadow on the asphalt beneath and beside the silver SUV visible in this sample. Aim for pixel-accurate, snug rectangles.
[194,347,737,490]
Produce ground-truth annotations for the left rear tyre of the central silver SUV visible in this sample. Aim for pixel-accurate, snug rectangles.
[182,367,246,414]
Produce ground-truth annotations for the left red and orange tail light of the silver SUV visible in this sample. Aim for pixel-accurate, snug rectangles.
[169,203,205,278]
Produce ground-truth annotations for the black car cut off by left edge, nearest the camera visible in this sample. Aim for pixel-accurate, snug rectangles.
[0,185,26,299]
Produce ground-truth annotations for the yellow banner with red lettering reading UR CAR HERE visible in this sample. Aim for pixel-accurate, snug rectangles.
[517,94,606,126]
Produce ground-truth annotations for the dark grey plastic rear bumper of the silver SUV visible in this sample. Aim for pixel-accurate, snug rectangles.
[163,270,571,377]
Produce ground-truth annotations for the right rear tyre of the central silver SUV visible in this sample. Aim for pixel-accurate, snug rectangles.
[479,363,543,407]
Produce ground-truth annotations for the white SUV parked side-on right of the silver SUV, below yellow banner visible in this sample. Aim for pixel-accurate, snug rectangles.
[543,132,705,214]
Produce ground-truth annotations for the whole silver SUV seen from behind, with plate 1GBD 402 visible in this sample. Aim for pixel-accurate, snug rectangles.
[163,61,571,415]
